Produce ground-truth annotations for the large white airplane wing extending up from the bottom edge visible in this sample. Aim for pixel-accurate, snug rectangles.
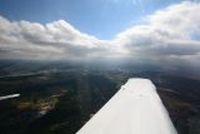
[77,78,177,134]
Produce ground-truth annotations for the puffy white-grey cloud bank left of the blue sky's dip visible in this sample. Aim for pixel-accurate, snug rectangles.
[0,17,115,59]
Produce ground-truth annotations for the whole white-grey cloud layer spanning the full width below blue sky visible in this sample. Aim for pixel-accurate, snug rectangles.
[0,2,200,66]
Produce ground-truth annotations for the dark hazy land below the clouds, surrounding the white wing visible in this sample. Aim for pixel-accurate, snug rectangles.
[0,61,200,134]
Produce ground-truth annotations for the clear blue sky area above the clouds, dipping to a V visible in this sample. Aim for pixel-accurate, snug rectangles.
[0,0,186,39]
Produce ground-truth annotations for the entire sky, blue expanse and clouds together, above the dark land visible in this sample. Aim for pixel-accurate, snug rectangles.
[0,0,200,73]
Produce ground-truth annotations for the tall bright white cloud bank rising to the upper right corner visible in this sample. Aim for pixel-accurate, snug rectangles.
[114,2,200,62]
